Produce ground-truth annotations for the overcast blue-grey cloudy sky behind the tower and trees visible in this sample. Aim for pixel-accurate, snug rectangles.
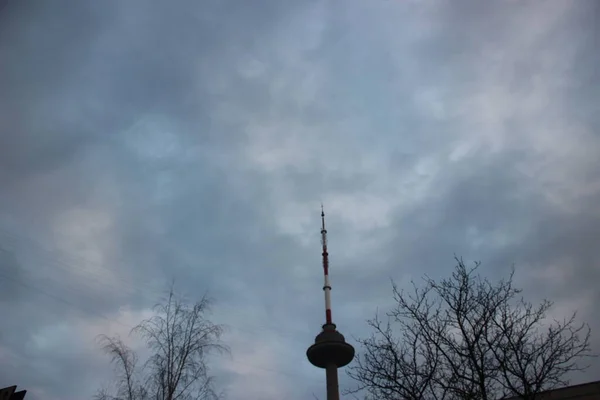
[0,0,600,400]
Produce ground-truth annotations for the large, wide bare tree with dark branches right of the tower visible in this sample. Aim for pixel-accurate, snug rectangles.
[347,258,592,400]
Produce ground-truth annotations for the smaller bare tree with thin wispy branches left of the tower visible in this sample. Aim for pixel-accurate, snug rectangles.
[96,288,229,400]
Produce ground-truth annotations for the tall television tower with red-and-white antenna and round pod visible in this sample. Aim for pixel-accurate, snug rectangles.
[306,204,354,400]
